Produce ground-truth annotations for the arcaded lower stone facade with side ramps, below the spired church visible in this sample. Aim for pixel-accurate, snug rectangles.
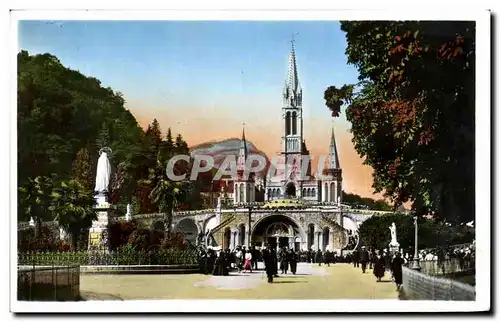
[130,203,391,252]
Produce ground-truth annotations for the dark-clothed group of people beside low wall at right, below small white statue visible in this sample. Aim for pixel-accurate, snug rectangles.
[352,246,407,290]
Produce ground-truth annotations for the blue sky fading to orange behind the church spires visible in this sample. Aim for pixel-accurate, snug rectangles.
[19,21,381,198]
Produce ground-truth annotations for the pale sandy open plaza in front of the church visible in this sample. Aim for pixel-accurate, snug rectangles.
[80,263,398,301]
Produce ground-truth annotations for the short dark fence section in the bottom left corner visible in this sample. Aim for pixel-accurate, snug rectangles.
[17,265,80,301]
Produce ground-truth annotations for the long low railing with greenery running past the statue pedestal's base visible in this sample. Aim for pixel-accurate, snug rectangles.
[17,249,197,266]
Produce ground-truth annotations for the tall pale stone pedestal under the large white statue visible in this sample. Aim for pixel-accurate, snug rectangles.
[88,197,116,250]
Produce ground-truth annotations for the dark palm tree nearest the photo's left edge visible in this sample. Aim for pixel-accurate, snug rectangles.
[19,176,53,238]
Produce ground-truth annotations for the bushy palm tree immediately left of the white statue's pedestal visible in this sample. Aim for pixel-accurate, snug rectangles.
[52,180,97,250]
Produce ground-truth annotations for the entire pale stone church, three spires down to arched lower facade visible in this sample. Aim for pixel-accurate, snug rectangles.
[136,45,390,253]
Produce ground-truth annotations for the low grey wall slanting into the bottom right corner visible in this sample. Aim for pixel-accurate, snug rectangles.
[403,267,476,301]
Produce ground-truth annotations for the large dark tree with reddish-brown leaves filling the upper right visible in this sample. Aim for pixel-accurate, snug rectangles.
[325,21,475,223]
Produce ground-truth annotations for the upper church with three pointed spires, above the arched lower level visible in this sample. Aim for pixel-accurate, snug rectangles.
[232,45,342,204]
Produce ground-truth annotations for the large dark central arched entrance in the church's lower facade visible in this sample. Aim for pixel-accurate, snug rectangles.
[251,215,303,251]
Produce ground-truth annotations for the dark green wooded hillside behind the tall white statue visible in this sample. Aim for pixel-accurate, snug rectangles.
[17,51,194,235]
